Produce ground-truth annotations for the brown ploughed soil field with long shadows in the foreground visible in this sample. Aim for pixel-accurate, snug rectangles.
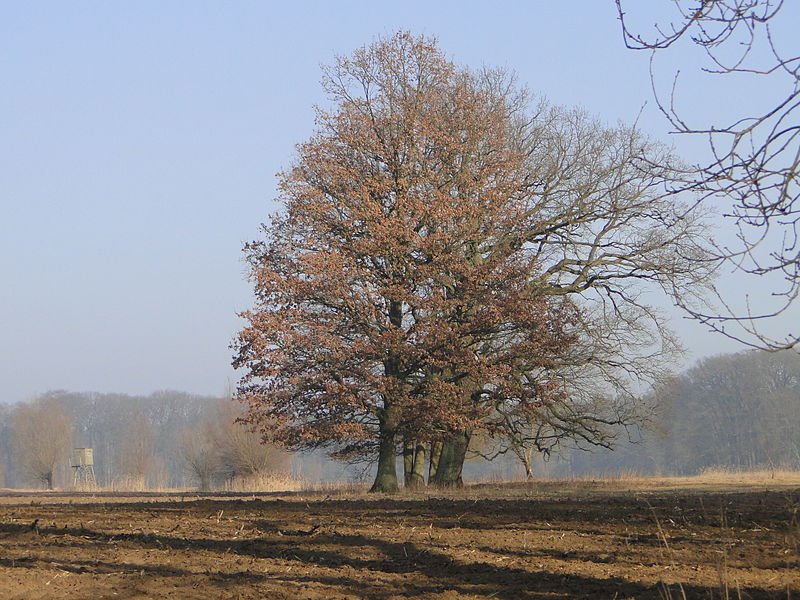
[0,482,800,600]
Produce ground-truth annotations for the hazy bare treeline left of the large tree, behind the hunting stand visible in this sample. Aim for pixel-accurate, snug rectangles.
[0,392,291,490]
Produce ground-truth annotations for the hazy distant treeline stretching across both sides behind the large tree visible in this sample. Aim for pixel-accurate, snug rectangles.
[0,351,800,489]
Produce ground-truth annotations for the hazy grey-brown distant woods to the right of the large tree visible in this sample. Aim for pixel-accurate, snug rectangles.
[556,351,800,474]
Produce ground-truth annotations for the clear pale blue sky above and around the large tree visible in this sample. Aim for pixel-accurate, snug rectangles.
[0,0,800,402]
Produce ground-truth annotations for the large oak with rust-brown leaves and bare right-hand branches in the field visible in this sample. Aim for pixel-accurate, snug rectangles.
[234,33,707,491]
